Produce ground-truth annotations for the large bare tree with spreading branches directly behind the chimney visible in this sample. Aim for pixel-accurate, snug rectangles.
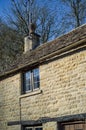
[8,0,60,43]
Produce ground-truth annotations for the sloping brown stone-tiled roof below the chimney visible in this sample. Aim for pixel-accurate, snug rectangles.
[0,24,86,77]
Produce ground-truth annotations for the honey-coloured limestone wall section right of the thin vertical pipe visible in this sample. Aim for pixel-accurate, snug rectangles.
[21,51,86,120]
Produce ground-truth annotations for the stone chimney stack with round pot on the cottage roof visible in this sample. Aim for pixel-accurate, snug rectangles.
[24,23,40,53]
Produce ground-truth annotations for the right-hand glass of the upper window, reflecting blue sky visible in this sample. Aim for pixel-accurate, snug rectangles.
[33,68,40,89]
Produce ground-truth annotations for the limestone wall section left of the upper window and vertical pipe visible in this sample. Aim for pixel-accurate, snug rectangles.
[0,74,20,130]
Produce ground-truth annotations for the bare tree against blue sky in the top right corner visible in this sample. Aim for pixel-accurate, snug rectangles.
[61,0,86,27]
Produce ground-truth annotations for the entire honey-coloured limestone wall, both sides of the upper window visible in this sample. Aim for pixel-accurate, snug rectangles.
[0,50,86,130]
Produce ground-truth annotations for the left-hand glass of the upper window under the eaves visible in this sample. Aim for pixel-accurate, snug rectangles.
[24,71,31,91]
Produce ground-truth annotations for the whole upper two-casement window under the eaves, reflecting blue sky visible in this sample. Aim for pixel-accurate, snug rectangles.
[23,68,40,93]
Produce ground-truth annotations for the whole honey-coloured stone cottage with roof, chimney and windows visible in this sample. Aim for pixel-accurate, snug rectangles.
[0,25,86,130]
